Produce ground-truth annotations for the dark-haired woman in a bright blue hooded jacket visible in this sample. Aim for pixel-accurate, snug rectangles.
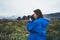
[27,9,49,40]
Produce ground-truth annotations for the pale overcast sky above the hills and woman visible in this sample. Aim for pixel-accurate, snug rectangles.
[0,0,60,17]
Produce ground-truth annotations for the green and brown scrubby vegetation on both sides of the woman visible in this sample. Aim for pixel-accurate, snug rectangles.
[0,20,60,40]
